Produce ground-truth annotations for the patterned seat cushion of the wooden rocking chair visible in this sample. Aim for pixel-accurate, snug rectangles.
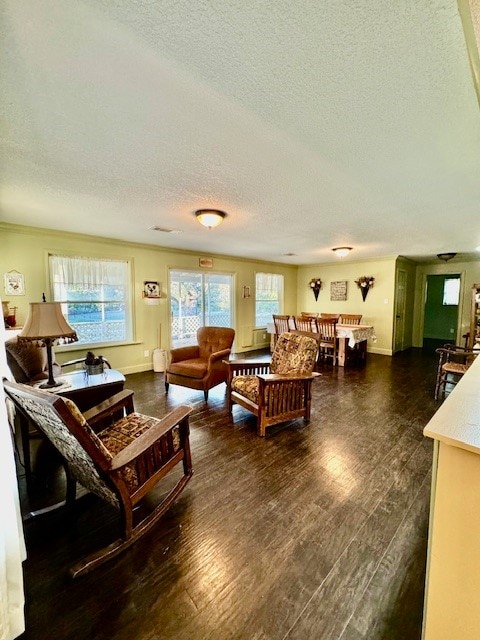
[98,413,180,490]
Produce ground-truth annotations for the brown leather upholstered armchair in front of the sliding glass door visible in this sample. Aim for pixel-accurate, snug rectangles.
[165,327,235,402]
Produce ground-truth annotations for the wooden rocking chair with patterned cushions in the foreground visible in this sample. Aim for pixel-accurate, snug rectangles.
[4,381,193,577]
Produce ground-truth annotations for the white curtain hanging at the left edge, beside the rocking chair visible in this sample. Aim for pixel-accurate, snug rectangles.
[0,300,26,640]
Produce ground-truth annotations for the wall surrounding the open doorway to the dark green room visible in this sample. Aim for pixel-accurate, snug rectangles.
[413,260,480,347]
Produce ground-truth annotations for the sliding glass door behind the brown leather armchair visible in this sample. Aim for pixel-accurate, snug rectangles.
[170,269,233,347]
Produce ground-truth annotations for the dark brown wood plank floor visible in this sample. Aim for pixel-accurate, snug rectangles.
[14,350,438,640]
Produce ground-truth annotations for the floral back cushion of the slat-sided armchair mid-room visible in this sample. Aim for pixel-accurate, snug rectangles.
[270,332,318,374]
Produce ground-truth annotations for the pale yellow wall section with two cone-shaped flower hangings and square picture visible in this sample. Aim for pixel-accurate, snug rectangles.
[297,258,396,355]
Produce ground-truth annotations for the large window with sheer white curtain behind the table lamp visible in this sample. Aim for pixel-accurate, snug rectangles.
[49,255,132,344]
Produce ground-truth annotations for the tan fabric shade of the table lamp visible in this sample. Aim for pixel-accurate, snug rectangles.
[18,302,78,342]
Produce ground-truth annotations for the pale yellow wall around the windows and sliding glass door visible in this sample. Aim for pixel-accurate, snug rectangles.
[0,224,297,373]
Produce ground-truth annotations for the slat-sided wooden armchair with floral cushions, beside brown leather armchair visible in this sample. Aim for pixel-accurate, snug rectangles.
[227,332,319,437]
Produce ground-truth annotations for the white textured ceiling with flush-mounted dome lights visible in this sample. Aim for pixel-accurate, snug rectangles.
[0,0,480,264]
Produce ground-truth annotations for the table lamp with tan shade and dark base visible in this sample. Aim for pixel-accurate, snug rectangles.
[17,302,78,389]
